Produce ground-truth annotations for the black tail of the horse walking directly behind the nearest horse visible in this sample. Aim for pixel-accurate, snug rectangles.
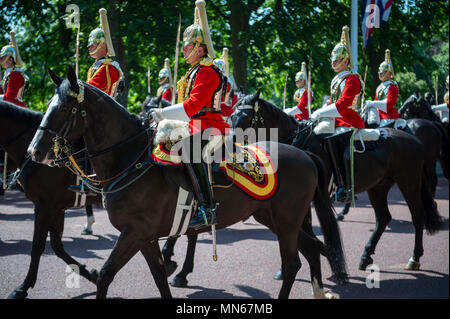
[421,169,444,235]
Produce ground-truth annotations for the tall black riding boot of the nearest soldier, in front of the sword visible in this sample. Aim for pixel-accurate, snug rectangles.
[185,163,216,228]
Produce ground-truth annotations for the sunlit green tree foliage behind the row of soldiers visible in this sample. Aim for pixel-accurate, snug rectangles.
[0,0,449,112]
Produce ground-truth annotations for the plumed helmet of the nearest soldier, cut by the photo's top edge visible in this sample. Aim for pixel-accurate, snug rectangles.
[183,0,215,59]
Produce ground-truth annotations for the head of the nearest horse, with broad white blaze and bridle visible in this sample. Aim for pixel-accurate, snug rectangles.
[28,66,87,166]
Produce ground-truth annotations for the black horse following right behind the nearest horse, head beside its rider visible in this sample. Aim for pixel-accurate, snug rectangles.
[232,91,443,270]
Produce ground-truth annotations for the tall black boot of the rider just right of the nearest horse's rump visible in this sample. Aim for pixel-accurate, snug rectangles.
[325,131,352,203]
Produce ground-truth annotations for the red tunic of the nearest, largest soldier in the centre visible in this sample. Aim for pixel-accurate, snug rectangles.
[183,65,230,134]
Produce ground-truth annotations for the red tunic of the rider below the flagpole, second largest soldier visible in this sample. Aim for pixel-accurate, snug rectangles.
[330,74,364,128]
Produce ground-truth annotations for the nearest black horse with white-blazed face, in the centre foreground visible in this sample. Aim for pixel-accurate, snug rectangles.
[29,67,347,298]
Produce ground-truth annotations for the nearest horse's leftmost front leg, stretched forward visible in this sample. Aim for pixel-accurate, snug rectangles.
[97,226,143,299]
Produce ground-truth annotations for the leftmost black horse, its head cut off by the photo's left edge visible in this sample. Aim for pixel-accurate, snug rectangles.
[0,101,101,298]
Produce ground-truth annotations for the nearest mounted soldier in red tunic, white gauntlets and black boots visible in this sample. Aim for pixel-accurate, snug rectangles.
[151,0,230,227]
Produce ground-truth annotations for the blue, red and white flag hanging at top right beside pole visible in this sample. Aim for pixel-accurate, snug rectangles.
[361,0,392,48]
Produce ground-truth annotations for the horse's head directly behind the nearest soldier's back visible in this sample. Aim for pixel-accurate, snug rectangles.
[231,89,261,129]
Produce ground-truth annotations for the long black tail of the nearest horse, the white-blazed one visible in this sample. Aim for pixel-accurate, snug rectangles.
[307,152,348,283]
